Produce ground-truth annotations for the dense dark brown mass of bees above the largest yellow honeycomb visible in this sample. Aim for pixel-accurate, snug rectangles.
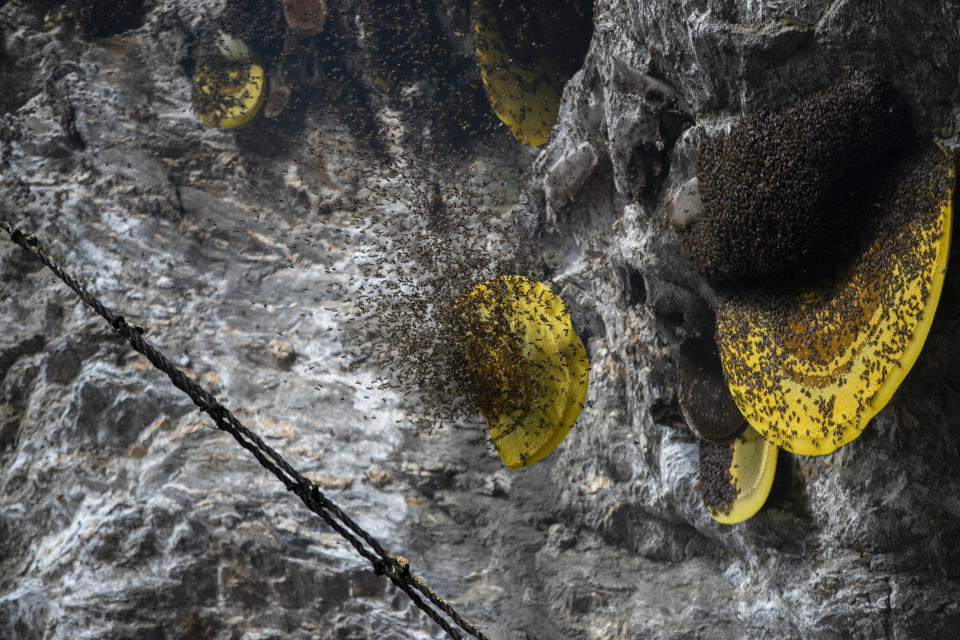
[680,71,910,284]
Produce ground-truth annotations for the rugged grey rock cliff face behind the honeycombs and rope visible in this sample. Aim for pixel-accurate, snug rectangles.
[0,0,960,640]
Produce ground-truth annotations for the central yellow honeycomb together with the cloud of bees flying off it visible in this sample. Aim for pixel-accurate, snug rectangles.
[344,144,587,468]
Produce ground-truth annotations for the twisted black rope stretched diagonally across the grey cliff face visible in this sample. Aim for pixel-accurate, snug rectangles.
[0,214,489,640]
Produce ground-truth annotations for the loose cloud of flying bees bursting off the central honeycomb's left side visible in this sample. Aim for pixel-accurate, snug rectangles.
[344,166,541,436]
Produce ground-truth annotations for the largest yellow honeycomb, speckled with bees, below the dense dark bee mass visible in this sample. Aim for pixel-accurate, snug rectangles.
[717,149,955,455]
